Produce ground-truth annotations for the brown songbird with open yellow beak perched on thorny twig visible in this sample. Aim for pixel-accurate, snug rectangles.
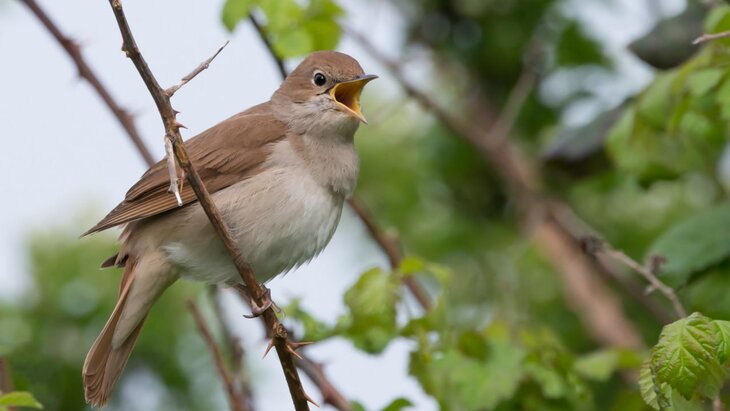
[82,51,377,407]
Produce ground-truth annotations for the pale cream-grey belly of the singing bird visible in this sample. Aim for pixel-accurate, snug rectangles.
[164,168,343,283]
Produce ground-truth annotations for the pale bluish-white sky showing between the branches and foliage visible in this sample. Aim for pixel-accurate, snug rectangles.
[0,0,683,411]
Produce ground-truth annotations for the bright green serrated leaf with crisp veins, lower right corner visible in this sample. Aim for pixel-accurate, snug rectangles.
[651,313,726,399]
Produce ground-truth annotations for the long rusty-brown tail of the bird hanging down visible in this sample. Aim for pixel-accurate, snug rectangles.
[83,253,176,407]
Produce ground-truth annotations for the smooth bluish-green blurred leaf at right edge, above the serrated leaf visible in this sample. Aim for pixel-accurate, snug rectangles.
[649,205,730,286]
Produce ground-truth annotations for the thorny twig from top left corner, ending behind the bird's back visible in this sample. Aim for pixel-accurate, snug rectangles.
[22,0,155,166]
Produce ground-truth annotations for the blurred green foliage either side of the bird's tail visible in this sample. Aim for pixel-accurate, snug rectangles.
[0,224,225,410]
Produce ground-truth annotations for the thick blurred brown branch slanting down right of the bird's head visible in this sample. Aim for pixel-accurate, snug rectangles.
[345,27,643,347]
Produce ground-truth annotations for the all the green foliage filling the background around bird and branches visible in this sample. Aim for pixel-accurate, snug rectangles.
[7,0,730,411]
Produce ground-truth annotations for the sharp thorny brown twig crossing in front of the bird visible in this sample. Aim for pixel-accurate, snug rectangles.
[104,0,309,411]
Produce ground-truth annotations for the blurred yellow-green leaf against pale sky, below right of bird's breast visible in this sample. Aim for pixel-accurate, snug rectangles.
[341,268,401,353]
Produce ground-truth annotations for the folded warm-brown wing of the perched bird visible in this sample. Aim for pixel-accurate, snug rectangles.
[83,103,286,235]
